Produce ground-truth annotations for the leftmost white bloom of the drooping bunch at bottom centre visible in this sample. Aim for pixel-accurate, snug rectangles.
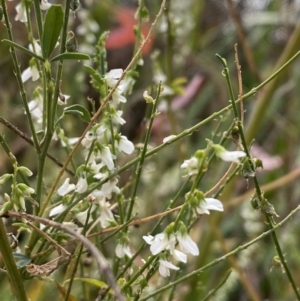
[143,232,176,255]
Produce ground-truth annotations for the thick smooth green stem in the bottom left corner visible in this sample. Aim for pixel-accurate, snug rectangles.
[0,218,28,301]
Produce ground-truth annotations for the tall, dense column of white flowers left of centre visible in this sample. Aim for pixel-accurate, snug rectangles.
[50,69,134,229]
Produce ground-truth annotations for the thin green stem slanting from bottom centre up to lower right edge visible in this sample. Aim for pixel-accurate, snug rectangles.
[140,206,300,301]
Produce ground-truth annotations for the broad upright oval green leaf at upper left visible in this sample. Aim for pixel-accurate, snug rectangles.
[42,5,64,59]
